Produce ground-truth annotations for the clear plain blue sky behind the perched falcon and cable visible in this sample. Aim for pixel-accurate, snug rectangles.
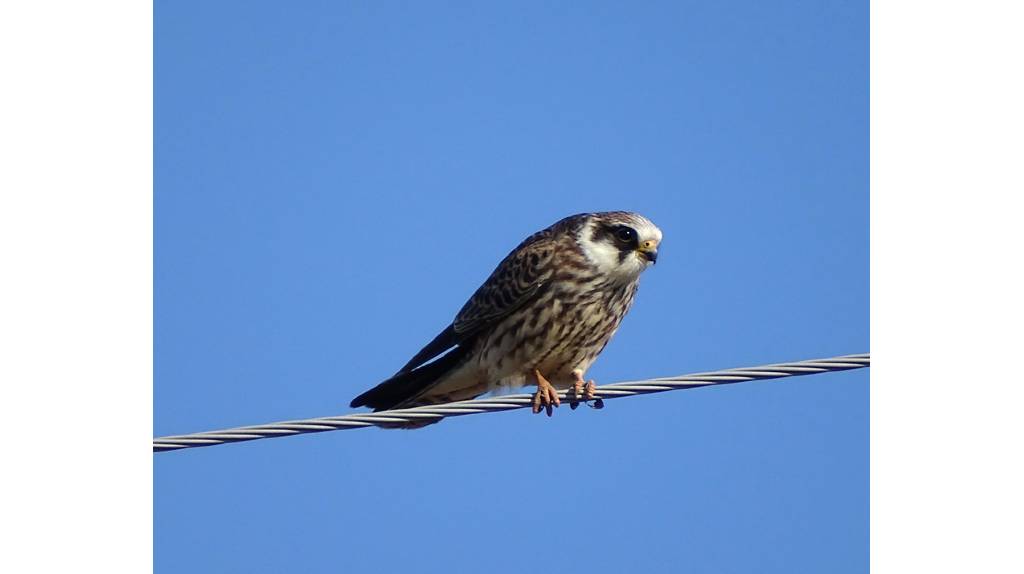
[154,0,869,574]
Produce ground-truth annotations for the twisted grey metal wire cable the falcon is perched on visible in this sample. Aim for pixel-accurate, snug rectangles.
[153,353,871,452]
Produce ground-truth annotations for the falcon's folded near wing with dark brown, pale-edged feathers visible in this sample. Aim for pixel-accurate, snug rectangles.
[398,228,556,374]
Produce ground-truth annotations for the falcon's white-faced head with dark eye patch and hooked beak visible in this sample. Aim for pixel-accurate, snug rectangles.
[577,211,662,279]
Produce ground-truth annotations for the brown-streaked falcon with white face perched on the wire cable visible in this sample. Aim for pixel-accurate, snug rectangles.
[351,212,662,427]
